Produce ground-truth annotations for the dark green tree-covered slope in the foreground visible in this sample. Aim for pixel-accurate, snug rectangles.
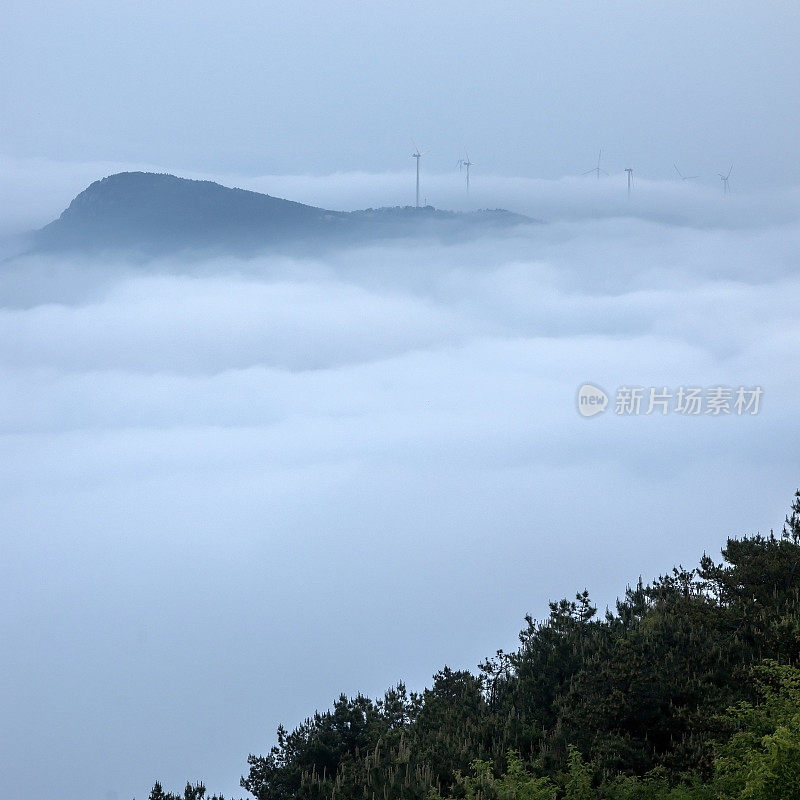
[150,491,800,800]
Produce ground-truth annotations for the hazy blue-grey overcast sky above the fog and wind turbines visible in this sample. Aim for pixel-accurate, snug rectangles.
[0,0,800,188]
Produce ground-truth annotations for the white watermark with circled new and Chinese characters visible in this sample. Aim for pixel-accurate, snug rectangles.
[578,383,764,417]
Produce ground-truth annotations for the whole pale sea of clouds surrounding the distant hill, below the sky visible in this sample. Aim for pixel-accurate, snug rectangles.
[0,156,800,800]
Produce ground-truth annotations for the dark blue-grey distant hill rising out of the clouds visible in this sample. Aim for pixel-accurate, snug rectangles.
[35,172,532,253]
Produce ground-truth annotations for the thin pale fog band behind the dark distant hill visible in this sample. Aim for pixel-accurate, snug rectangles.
[0,155,800,244]
